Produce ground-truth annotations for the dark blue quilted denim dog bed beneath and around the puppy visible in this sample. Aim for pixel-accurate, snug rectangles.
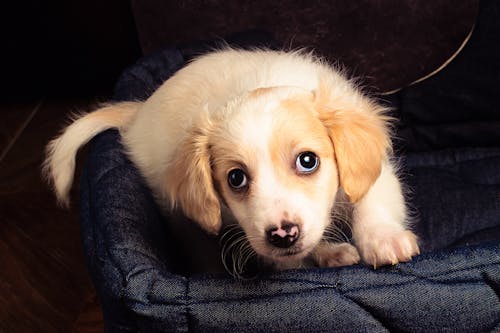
[80,6,500,333]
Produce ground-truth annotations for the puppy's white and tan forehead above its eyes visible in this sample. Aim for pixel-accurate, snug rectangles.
[218,88,332,163]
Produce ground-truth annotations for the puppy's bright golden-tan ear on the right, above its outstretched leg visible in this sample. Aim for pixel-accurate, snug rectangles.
[315,84,391,203]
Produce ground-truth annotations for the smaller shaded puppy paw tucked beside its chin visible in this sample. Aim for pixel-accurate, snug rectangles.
[312,242,361,267]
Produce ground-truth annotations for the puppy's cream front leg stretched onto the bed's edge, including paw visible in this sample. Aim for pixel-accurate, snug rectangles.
[353,162,419,267]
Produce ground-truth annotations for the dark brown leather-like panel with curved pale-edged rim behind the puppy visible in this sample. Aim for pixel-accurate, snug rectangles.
[132,0,479,92]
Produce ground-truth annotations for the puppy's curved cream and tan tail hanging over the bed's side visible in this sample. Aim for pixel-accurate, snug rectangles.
[42,102,140,207]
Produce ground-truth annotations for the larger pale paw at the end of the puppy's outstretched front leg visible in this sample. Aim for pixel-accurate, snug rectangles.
[357,228,420,268]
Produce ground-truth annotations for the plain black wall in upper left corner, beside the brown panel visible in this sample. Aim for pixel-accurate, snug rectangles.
[1,0,140,99]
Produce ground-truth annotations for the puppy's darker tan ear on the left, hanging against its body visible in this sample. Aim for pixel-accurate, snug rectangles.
[164,130,221,234]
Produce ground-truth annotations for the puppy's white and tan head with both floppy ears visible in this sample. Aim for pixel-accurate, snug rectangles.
[166,85,389,264]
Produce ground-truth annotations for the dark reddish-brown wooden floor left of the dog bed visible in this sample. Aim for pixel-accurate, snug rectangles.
[0,99,103,333]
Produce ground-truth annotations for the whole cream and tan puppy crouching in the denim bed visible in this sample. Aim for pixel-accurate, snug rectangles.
[44,49,419,269]
